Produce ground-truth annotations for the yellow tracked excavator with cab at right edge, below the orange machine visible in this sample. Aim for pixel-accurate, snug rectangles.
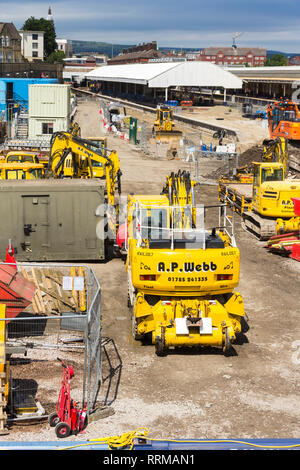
[219,137,300,240]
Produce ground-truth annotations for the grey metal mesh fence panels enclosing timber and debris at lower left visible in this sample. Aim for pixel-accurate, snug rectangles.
[0,263,102,421]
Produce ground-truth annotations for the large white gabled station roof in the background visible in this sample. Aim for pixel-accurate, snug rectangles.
[86,61,243,89]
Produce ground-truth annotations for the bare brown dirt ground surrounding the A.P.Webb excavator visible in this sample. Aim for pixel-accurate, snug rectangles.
[0,97,300,441]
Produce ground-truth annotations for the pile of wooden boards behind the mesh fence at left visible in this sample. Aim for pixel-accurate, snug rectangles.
[21,267,84,315]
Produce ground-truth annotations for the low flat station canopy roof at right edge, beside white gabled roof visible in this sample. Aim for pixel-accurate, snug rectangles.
[224,65,300,83]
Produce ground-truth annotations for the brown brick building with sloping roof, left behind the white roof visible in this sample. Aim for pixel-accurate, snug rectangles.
[107,41,165,65]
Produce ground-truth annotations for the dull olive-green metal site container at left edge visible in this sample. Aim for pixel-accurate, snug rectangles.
[0,179,105,261]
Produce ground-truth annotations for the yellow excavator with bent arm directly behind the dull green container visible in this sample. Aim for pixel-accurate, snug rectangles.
[48,131,121,206]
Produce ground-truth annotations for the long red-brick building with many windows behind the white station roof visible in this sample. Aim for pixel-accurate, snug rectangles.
[199,47,267,67]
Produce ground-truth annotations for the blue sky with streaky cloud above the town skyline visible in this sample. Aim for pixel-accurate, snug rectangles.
[0,0,300,53]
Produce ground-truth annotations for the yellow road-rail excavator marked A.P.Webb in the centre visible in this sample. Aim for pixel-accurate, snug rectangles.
[125,172,245,356]
